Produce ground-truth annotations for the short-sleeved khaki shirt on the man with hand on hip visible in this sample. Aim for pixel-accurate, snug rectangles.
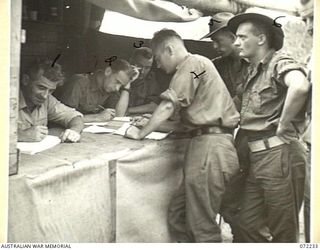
[240,50,305,134]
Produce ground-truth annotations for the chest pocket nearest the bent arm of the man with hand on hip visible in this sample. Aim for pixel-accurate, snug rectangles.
[251,82,278,114]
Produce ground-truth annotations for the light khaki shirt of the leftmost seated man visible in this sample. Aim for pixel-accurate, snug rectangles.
[18,91,82,130]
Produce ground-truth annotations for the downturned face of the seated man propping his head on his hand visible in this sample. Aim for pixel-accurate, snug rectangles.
[103,71,130,93]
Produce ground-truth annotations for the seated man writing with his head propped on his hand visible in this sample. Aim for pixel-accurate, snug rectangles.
[60,59,139,122]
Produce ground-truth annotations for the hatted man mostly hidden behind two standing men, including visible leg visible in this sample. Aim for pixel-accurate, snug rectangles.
[201,12,249,229]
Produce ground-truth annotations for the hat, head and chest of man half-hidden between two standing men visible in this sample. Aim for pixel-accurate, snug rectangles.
[201,12,248,97]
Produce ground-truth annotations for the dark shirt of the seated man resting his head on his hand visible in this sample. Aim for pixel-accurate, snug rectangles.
[60,74,116,114]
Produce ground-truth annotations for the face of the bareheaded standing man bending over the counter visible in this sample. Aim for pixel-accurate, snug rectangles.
[152,45,176,74]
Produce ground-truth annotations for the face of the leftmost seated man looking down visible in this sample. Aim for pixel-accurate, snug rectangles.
[26,76,56,106]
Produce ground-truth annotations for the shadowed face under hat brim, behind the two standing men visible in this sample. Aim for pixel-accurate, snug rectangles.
[211,30,235,57]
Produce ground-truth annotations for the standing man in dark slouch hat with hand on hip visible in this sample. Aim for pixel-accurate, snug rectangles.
[228,13,310,242]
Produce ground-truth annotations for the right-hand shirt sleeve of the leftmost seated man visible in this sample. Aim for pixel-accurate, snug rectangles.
[48,95,83,127]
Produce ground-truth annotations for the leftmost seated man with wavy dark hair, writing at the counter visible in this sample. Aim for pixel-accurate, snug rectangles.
[18,61,83,142]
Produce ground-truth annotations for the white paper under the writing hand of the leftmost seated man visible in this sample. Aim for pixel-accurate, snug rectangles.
[17,135,61,155]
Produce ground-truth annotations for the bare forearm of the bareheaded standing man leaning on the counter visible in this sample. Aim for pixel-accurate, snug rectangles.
[140,101,174,138]
